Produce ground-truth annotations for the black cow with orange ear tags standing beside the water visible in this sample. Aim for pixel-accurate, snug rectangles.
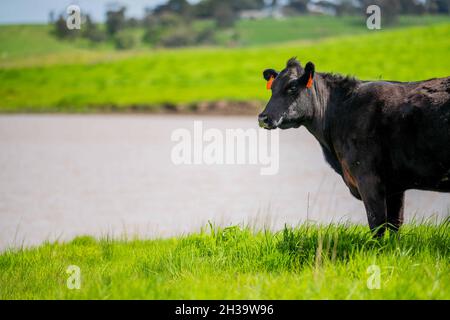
[259,58,450,236]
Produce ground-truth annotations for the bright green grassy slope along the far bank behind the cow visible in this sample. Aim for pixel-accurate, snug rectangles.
[0,19,450,112]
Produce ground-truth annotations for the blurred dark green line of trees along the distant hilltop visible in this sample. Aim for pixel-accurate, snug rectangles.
[51,0,450,49]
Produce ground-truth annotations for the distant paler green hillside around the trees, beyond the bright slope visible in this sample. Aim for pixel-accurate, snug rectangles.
[0,15,449,60]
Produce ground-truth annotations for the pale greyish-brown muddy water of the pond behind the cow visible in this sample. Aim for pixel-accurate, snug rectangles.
[0,115,450,249]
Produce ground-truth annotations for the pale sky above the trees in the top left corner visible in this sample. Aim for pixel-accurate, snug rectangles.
[0,0,171,24]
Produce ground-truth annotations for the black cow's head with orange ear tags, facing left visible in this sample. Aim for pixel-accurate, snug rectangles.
[258,58,314,129]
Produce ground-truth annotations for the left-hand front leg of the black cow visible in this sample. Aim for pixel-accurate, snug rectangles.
[358,174,387,237]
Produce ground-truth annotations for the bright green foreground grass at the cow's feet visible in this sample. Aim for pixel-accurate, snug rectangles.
[0,220,450,299]
